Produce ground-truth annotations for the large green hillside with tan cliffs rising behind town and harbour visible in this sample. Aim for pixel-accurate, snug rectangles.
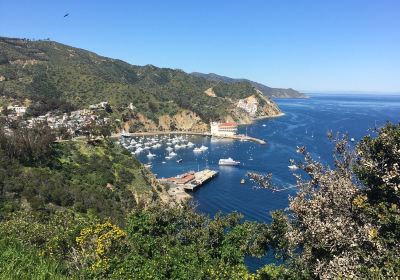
[0,37,280,130]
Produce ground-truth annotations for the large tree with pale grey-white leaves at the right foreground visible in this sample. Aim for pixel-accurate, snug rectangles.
[262,125,400,279]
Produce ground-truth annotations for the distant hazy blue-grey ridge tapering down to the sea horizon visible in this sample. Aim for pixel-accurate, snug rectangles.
[191,72,306,98]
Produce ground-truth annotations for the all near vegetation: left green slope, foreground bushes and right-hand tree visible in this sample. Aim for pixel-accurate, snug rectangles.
[0,116,400,280]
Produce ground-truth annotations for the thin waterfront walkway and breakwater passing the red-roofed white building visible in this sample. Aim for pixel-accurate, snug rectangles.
[118,131,267,145]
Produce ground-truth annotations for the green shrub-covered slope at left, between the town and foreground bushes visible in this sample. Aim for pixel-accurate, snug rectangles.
[0,123,153,223]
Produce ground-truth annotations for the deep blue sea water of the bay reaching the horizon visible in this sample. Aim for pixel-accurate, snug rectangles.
[132,94,400,268]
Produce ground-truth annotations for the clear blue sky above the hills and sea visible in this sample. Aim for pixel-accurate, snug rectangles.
[0,0,400,92]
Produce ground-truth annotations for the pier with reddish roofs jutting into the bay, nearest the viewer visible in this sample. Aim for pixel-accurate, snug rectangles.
[158,169,218,191]
